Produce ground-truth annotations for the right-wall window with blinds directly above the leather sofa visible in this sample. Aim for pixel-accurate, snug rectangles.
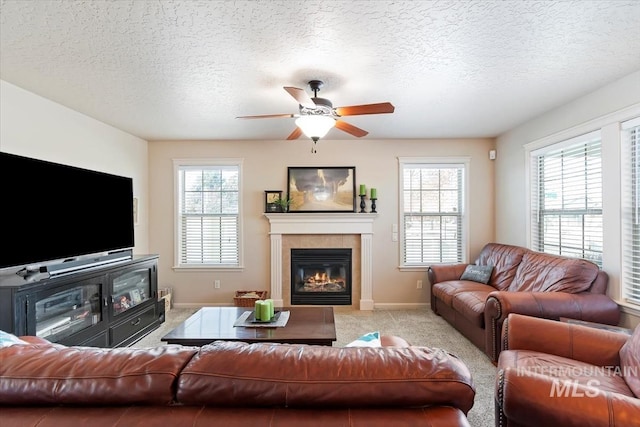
[531,131,603,267]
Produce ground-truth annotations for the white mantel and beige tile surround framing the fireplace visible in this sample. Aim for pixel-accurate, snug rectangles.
[264,212,377,310]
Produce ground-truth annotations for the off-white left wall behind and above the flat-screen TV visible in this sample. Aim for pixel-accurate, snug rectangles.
[0,80,149,260]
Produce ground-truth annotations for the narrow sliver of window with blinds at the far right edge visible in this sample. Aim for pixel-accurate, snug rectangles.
[621,117,640,304]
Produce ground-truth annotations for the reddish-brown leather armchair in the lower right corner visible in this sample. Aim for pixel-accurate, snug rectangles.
[495,314,640,427]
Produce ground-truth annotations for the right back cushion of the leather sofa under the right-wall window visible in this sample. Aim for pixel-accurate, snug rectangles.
[509,251,599,294]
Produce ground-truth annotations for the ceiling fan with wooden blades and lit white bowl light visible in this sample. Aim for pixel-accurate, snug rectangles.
[236,80,395,143]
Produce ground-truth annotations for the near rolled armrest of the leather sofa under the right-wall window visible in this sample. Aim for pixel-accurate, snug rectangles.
[484,291,620,362]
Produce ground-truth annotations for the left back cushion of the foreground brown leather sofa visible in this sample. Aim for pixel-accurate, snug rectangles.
[0,344,197,405]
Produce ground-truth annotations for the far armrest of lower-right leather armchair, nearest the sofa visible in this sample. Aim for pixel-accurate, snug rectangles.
[502,313,629,366]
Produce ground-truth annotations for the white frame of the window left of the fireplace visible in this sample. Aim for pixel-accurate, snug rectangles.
[173,158,244,271]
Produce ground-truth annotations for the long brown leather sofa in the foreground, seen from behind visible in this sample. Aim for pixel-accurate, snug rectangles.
[0,337,475,427]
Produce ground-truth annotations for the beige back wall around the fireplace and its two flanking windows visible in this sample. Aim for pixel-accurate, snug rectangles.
[149,139,494,307]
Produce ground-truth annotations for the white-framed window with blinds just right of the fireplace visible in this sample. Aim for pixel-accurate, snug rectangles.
[400,158,468,266]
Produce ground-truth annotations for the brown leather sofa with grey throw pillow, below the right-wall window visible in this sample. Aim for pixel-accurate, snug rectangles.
[428,243,620,363]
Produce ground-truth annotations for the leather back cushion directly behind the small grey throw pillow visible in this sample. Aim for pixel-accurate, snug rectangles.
[476,243,527,291]
